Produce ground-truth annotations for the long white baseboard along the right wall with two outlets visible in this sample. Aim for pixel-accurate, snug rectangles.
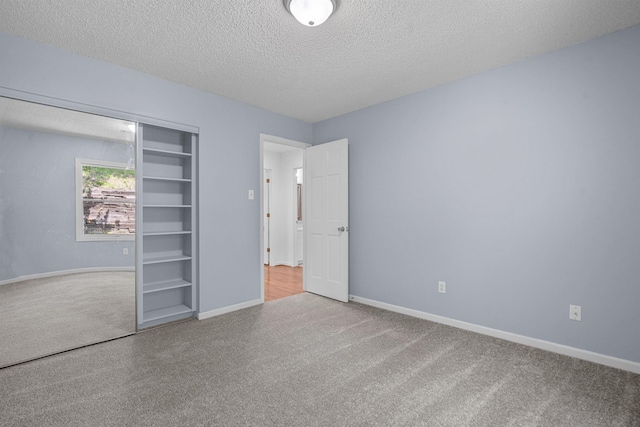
[349,295,640,374]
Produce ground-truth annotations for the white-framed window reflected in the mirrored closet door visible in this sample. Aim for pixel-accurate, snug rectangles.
[76,159,136,241]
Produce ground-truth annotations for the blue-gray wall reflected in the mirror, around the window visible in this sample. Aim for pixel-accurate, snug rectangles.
[0,126,135,281]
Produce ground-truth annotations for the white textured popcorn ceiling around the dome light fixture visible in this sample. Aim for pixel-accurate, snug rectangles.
[0,0,640,123]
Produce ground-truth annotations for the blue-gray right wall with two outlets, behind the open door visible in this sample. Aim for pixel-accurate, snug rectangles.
[314,26,640,362]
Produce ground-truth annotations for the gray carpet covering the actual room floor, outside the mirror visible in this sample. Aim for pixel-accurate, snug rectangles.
[0,294,640,427]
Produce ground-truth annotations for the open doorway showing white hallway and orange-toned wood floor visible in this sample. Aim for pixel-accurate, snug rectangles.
[260,135,308,301]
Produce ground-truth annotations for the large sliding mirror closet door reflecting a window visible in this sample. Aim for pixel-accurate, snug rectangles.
[0,97,136,366]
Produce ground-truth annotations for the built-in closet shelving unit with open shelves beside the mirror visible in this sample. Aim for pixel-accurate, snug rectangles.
[136,124,197,329]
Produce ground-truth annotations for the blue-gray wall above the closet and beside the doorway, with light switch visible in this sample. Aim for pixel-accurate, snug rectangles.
[0,34,312,311]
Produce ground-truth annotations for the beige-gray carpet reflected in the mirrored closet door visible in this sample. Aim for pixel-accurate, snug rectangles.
[0,271,136,366]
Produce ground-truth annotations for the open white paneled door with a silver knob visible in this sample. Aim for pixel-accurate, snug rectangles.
[304,139,349,302]
